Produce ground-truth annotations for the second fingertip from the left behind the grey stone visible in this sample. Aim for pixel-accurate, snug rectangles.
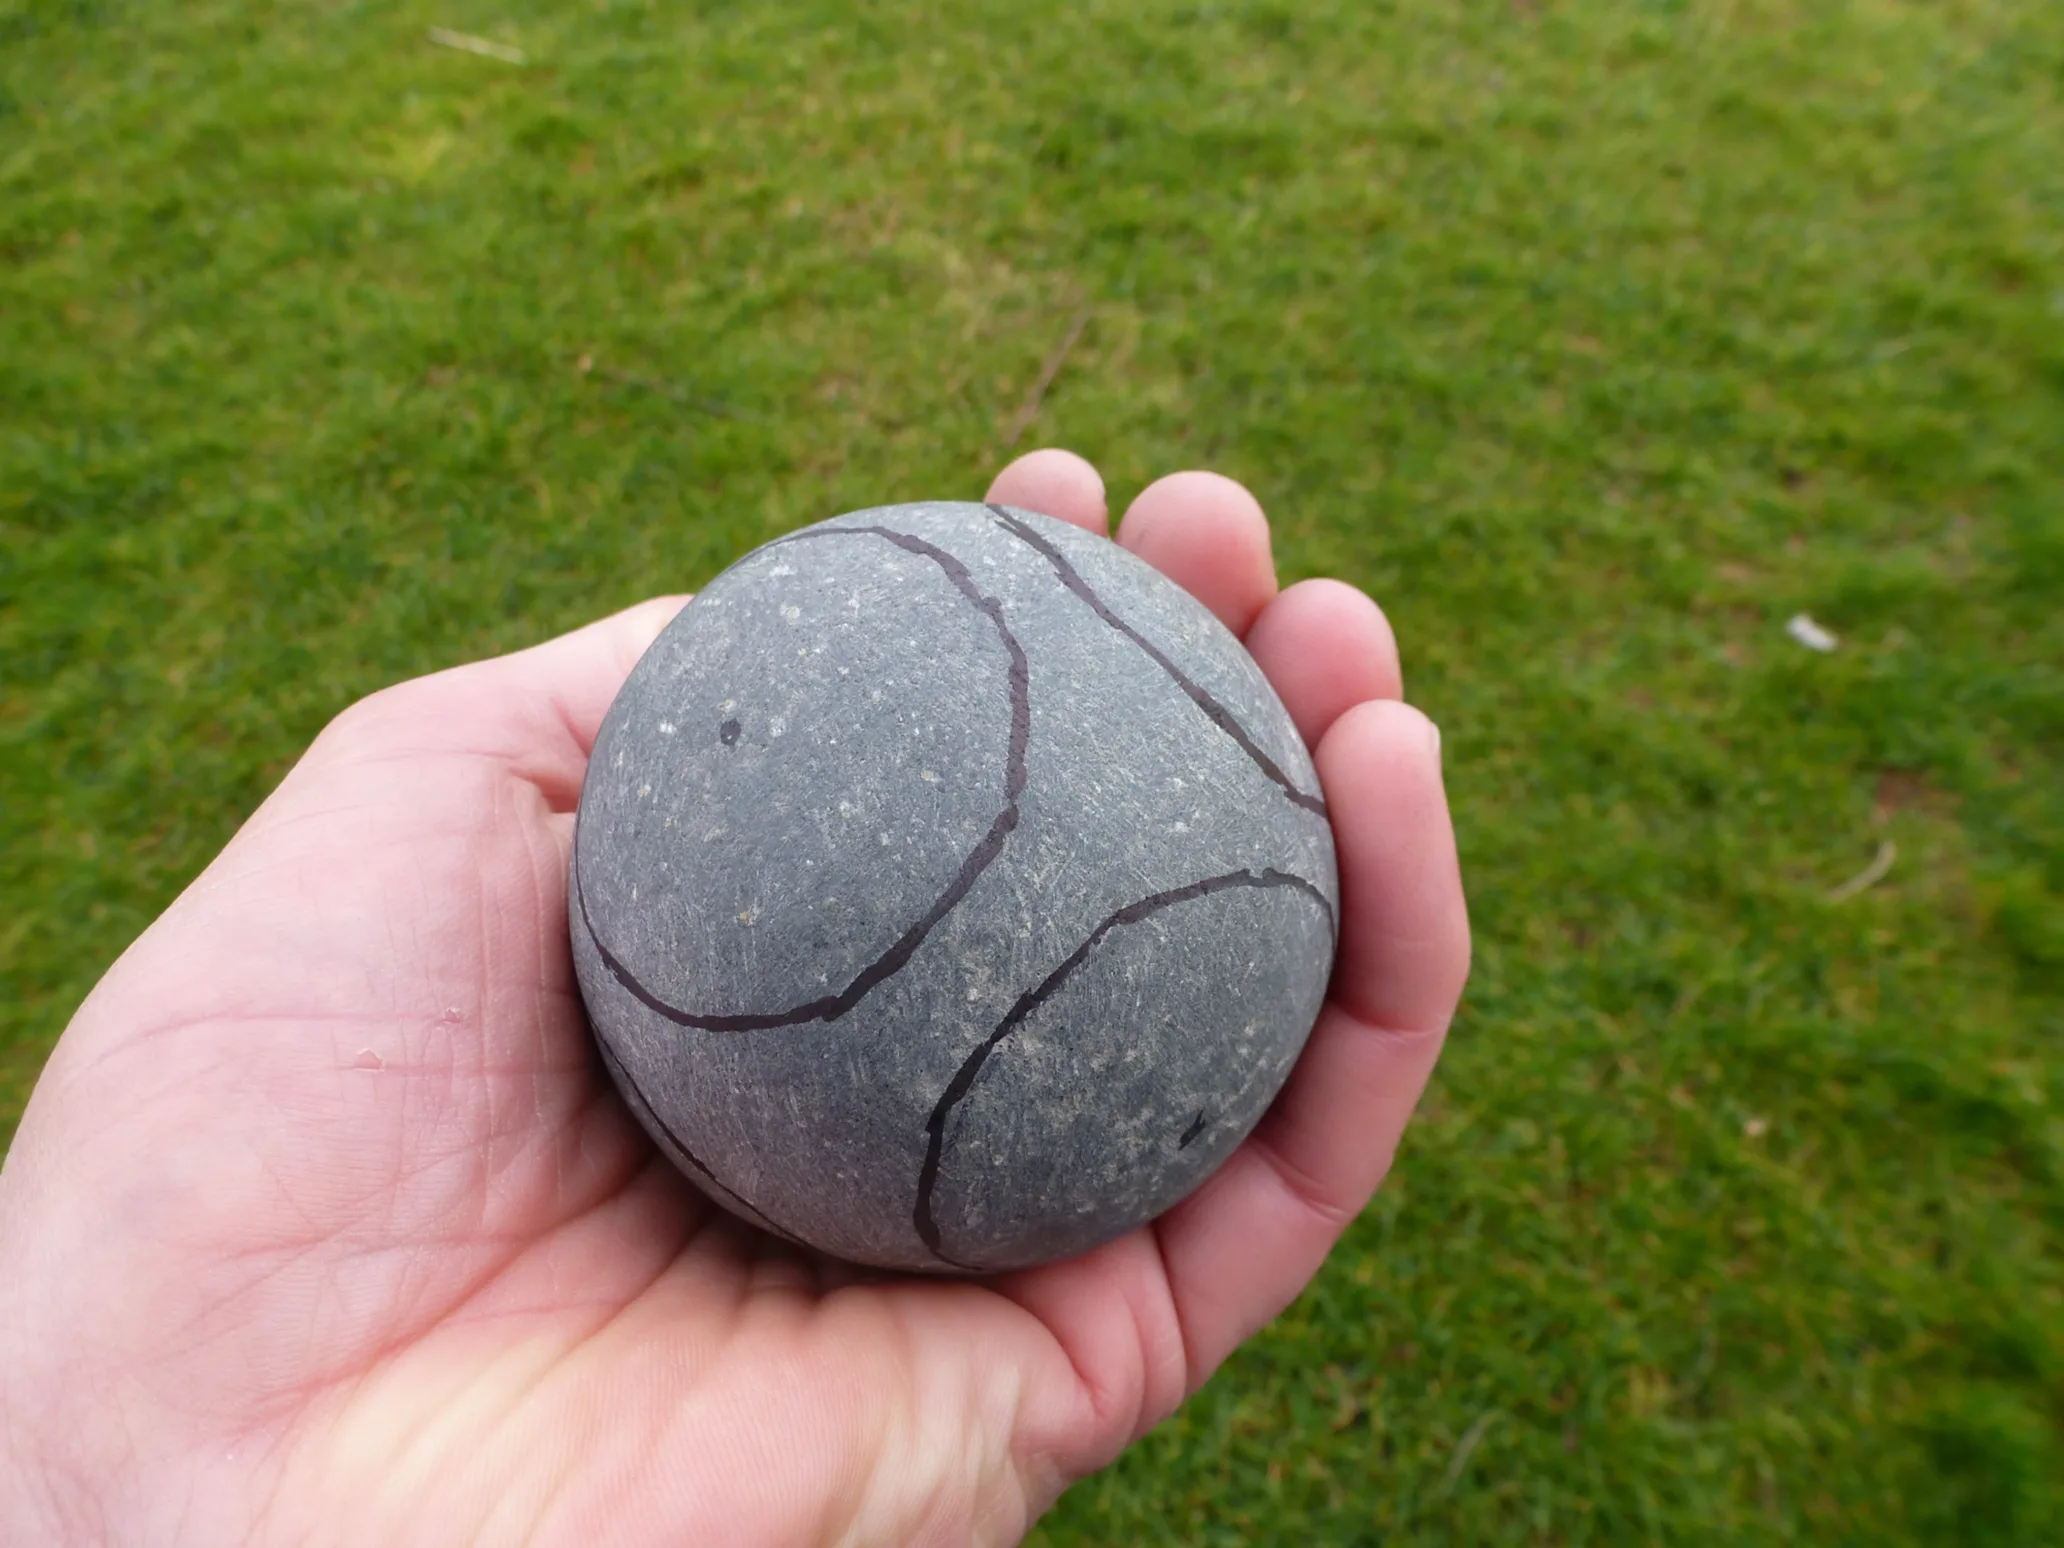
[1119,471,1276,636]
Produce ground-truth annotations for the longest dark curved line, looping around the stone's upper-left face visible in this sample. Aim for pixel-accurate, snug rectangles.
[574,526,1032,1032]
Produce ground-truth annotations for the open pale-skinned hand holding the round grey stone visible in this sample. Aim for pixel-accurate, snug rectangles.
[0,450,1470,1548]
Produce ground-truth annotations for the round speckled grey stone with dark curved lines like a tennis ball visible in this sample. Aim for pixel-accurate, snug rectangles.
[570,504,1337,1271]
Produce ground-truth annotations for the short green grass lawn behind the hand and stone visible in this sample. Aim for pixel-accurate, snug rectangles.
[0,0,2064,1548]
